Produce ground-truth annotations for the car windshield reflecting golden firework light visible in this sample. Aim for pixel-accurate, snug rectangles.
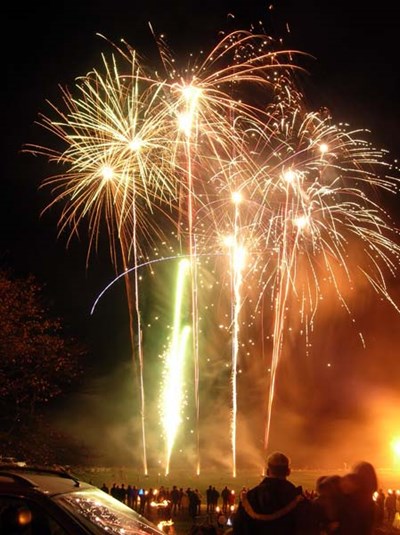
[55,489,162,535]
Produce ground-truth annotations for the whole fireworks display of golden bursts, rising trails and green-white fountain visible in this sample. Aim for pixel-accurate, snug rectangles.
[26,26,399,476]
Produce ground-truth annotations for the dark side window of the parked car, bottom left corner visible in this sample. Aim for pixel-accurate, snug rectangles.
[0,496,68,535]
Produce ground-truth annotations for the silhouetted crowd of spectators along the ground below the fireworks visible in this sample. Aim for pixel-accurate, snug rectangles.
[101,463,400,535]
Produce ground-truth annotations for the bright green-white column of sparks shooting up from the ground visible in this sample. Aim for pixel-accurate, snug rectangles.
[161,259,190,475]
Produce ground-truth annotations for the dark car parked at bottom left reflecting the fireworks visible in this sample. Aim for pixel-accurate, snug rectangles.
[0,462,165,535]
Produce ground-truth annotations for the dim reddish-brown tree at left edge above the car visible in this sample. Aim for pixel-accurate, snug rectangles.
[0,270,86,460]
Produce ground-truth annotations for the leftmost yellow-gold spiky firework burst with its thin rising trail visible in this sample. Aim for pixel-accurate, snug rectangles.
[23,45,183,474]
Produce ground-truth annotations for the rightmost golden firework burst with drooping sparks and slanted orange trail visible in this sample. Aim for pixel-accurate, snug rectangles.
[248,93,400,448]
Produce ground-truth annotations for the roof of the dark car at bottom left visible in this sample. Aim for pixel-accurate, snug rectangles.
[0,463,93,495]
